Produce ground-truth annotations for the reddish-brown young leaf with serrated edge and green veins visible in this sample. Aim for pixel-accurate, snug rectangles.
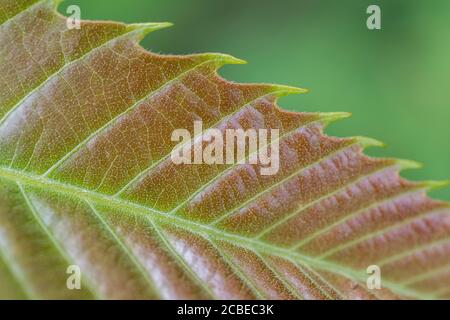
[0,0,450,299]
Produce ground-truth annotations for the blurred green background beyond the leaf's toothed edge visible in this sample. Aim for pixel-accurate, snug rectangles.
[60,0,450,200]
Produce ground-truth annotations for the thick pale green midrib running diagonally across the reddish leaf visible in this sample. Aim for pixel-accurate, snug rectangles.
[0,167,433,299]
